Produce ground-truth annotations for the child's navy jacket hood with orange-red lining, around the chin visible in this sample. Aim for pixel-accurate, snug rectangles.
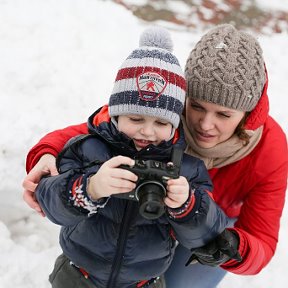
[87,105,186,161]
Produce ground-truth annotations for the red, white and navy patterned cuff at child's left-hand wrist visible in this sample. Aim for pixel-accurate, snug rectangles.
[68,174,109,216]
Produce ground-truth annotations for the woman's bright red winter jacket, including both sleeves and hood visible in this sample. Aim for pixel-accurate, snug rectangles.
[26,78,288,274]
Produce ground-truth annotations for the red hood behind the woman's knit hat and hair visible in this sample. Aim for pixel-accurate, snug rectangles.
[244,68,269,130]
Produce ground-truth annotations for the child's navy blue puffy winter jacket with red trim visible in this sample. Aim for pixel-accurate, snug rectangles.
[36,109,227,288]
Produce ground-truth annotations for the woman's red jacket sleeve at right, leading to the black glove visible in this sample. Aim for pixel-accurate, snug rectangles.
[221,119,288,275]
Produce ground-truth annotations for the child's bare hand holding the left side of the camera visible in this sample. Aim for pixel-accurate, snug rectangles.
[87,156,138,200]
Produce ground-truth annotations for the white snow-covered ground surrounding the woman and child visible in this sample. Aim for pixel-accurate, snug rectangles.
[0,0,288,288]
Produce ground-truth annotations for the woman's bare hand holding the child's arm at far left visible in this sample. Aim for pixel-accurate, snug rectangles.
[22,154,58,217]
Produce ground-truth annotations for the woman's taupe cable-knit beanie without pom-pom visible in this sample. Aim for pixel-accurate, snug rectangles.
[185,24,266,111]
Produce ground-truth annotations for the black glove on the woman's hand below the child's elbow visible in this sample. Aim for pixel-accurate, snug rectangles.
[185,229,242,267]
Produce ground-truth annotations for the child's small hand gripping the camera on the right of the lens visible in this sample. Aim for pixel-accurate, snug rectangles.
[164,176,189,208]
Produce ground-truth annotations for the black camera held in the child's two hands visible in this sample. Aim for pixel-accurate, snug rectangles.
[114,149,183,220]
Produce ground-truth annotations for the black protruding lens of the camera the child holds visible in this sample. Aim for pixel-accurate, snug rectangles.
[136,181,166,220]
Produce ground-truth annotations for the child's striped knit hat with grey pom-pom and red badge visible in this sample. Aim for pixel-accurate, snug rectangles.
[109,27,186,128]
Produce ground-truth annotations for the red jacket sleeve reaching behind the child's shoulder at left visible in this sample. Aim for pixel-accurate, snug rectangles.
[26,122,88,173]
